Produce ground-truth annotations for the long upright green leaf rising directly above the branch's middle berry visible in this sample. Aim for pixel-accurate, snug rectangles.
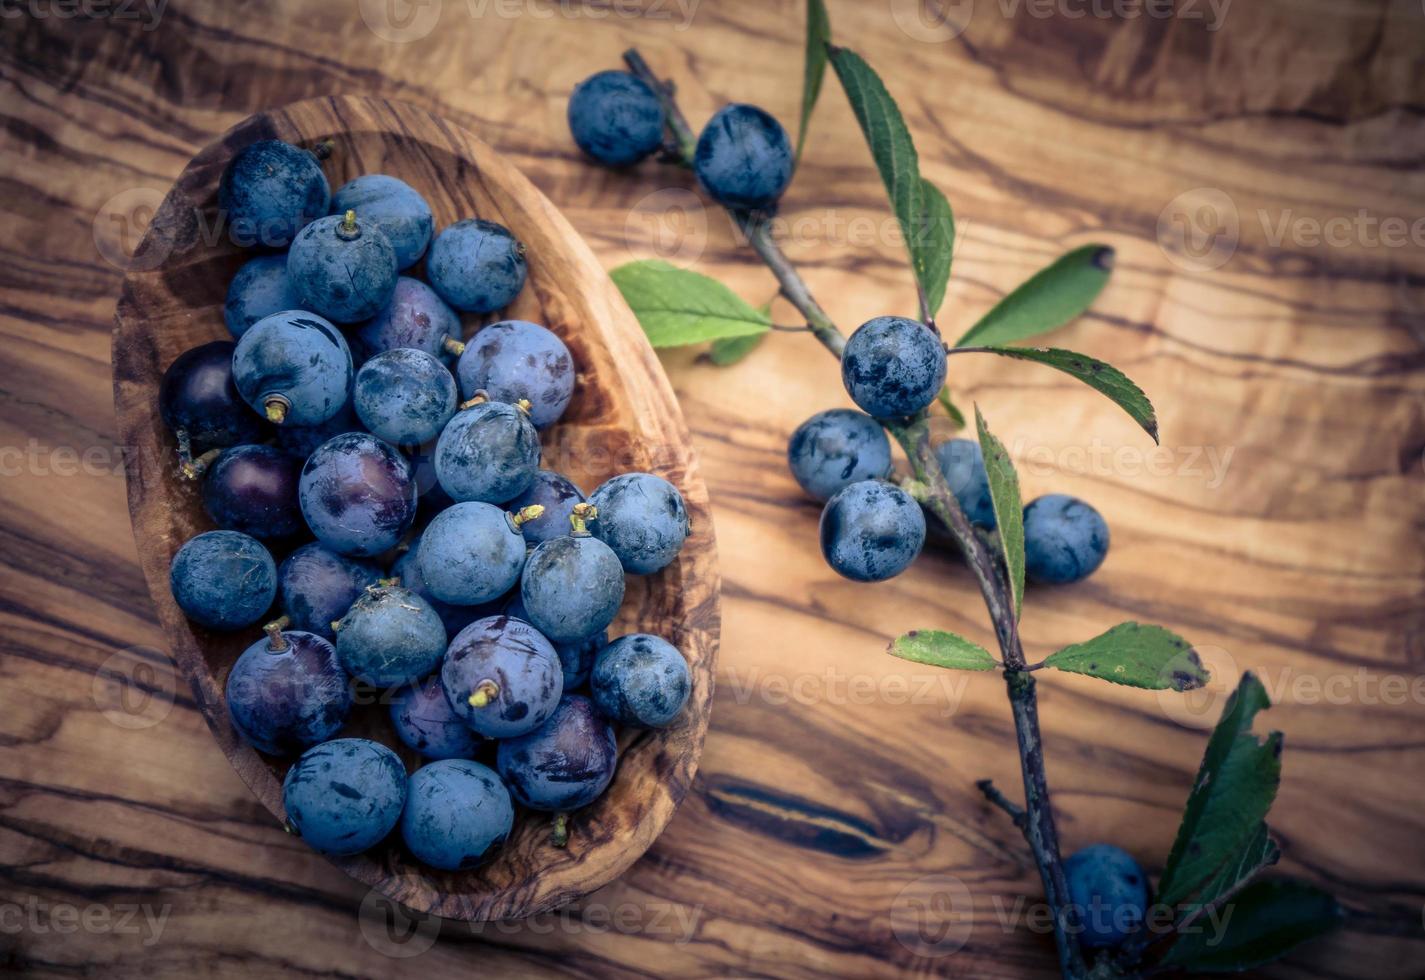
[828,46,955,318]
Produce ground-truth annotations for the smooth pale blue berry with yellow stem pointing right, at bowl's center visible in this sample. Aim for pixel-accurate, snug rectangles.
[416,500,527,605]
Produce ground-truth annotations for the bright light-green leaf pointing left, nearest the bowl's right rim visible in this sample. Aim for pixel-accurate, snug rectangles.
[608,259,772,348]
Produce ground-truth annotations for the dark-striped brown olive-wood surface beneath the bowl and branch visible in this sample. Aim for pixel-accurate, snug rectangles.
[0,0,1425,977]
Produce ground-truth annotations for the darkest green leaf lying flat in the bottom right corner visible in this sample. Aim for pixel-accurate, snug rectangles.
[1163,880,1345,973]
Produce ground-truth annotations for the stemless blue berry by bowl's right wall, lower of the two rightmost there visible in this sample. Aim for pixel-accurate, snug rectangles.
[589,632,693,728]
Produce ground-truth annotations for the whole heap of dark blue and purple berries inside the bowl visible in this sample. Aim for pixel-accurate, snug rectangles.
[160,140,691,870]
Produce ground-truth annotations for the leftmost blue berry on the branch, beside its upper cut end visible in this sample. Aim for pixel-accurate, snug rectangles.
[569,71,664,167]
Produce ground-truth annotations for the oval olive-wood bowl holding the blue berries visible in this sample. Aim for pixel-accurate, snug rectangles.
[114,98,718,920]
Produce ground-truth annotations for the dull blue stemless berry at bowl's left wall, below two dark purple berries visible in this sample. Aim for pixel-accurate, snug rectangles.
[168,531,276,630]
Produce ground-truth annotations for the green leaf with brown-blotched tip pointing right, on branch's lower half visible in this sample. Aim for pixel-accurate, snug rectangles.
[1045,622,1208,691]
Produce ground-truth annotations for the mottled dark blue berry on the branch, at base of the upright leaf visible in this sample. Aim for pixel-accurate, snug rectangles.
[841,316,945,419]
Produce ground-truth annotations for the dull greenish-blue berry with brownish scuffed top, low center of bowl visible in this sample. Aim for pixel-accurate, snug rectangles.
[336,585,446,688]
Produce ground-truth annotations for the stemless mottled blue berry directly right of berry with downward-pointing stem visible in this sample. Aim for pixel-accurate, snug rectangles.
[352,348,456,446]
